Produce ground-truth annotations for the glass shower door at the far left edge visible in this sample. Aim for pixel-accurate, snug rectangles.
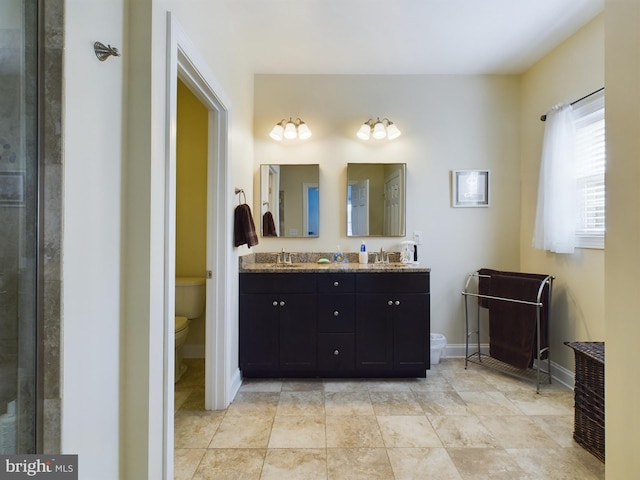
[0,0,38,454]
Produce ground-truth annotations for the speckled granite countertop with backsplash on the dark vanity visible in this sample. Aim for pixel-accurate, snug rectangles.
[239,252,431,273]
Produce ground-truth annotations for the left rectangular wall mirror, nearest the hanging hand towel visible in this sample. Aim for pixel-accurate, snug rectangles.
[260,164,320,237]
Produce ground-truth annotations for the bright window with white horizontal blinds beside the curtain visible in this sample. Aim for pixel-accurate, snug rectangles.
[573,90,606,248]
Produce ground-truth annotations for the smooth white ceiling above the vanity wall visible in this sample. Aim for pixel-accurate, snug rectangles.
[225,0,604,74]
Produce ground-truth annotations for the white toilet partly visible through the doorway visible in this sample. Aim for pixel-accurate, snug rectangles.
[174,277,206,382]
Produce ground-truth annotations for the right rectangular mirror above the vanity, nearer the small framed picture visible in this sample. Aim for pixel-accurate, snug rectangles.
[347,163,407,237]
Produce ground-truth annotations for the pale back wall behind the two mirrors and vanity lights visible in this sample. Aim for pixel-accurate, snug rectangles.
[252,75,520,345]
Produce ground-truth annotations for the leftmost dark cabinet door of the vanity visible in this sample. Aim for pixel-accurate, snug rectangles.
[239,293,280,374]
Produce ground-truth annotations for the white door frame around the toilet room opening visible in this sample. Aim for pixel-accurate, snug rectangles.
[163,12,231,480]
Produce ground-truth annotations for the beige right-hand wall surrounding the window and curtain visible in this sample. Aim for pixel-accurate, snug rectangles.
[520,15,605,371]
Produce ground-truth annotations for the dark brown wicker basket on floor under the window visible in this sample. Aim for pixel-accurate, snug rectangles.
[565,342,604,462]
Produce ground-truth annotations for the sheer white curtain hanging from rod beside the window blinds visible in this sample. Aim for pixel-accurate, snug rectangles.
[533,104,576,253]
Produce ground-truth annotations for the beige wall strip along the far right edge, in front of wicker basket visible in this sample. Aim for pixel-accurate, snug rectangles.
[605,0,640,472]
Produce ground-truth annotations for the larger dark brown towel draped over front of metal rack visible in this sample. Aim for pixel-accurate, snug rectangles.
[489,273,546,369]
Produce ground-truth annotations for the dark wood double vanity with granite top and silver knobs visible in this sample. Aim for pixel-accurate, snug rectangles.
[239,256,430,377]
